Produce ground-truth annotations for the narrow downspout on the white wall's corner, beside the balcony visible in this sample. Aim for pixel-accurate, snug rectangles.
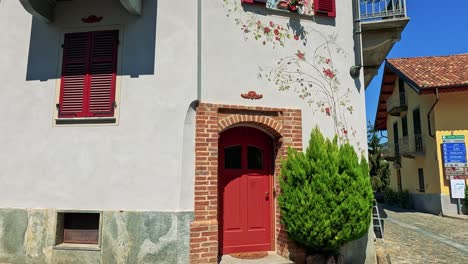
[349,0,362,78]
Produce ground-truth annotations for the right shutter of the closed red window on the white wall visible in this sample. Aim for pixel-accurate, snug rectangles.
[88,31,118,116]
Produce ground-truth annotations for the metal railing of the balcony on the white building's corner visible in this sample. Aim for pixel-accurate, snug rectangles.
[360,0,406,21]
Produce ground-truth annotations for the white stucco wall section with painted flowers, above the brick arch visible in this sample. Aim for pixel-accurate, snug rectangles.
[202,0,367,156]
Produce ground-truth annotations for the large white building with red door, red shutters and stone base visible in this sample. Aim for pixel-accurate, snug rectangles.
[0,0,408,264]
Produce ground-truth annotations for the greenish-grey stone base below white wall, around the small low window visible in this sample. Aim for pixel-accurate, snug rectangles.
[0,209,193,264]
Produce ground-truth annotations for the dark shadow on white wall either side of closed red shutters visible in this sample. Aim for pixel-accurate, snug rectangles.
[25,0,158,81]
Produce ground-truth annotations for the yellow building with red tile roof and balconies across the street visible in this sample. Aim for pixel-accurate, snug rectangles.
[375,54,468,214]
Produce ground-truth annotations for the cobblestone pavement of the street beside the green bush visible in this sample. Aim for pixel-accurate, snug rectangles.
[377,206,468,264]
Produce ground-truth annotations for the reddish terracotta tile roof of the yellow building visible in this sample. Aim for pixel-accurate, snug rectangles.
[387,53,468,89]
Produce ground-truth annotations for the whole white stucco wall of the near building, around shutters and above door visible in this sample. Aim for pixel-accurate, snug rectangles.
[0,0,366,211]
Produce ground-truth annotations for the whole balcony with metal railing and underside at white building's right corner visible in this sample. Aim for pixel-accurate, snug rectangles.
[359,0,409,87]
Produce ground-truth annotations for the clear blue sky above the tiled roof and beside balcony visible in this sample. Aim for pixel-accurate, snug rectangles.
[366,0,468,124]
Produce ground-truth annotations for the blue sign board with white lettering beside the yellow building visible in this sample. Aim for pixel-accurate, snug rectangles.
[442,135,468,179]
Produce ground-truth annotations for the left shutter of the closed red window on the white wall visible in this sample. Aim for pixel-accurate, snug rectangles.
[59,33,91,117]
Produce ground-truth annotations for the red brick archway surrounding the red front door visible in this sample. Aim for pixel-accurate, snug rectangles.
[190,103,302,264]
